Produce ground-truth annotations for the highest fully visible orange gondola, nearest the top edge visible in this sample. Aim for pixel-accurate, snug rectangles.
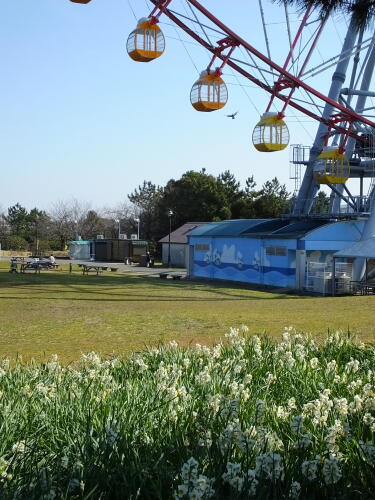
[126,19,165,62]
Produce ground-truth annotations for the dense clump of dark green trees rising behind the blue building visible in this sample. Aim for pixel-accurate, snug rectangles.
[128,169,289,240]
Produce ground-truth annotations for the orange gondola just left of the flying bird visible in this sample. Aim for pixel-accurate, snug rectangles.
[190,70,228,112]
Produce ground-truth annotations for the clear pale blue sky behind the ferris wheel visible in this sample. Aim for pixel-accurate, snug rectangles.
[0,0,345,209]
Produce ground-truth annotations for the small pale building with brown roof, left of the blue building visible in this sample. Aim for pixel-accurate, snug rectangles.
[159,222,208,268]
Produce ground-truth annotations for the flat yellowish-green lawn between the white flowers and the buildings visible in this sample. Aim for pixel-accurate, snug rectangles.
[0,262,375,361]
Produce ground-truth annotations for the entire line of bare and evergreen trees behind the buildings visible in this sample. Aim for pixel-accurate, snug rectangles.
[0,169,306,252]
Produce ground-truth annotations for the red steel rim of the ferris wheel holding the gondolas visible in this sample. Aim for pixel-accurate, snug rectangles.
[150,0,375,140]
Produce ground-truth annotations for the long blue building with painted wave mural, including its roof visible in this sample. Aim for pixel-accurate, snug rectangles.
[188,219,364,289]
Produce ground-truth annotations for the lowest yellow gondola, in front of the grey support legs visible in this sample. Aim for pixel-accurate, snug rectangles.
[314,146,350,184]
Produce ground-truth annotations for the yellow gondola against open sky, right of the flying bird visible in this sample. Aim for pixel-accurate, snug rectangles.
[253,112,289,153]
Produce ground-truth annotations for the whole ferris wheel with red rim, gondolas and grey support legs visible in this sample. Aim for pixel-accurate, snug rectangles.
[71,0,375,227]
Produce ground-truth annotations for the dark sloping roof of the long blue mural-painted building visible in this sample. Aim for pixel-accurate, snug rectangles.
[191,219,327,238]
